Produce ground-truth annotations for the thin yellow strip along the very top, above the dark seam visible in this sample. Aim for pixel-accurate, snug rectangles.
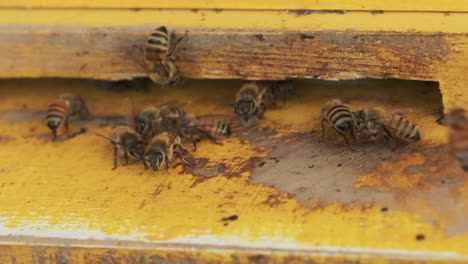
[0,0,468,12]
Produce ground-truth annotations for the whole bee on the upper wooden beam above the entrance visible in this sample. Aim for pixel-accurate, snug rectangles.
[144,26,185,87]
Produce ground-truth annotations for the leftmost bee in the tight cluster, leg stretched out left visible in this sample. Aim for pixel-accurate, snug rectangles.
[96,126,146,170]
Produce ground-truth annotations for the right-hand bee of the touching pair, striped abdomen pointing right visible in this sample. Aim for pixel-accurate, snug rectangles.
[354,107,421,148]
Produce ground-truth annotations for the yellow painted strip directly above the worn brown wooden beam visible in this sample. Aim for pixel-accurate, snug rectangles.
[0,9,468,34]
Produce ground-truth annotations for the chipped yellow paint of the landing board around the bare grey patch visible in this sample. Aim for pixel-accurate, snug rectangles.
[0,80,468,260]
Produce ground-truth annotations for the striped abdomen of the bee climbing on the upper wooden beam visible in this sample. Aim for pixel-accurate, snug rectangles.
[145,27,169,61]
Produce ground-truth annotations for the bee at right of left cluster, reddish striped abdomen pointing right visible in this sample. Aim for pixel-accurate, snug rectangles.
[179,115,231,151]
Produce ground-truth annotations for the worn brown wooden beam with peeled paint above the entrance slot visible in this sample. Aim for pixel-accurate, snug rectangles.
[0,26,458,80]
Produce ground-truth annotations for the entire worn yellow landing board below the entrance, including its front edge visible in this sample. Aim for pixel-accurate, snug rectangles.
[0,79,468,264]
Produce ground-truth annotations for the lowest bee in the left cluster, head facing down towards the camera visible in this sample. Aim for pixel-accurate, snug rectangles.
[143,132,190,171]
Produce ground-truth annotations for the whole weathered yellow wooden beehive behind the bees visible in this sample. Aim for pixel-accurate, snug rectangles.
[0,0,468,264]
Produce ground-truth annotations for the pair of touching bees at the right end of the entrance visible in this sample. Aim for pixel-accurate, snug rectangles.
[321,99,421,148]
